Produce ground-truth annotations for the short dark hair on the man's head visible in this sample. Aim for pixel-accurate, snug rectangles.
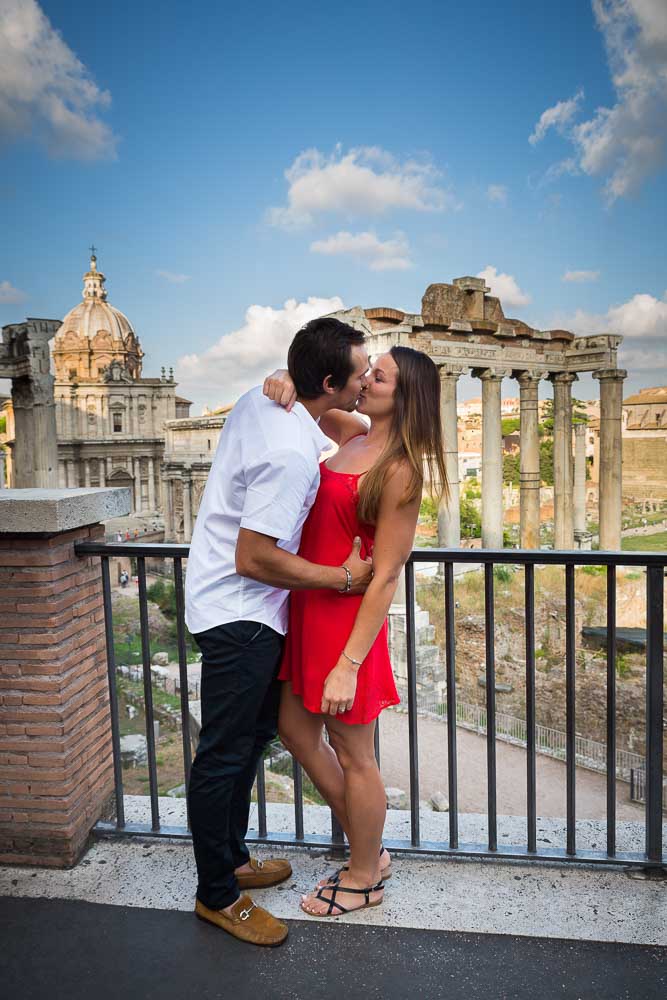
[287,316,365,399]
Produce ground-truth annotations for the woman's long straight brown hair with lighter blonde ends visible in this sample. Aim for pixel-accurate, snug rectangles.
[357,347,449,524]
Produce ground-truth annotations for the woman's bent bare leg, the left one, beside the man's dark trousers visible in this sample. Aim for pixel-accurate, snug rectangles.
[278,681,348,833]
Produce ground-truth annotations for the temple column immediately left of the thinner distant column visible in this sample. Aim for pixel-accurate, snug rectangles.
[551,372,577,549]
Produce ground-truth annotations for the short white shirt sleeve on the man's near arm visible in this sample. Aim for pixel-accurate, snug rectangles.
[241,448,313,541]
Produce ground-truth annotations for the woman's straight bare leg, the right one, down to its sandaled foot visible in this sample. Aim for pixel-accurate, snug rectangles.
[301,717,387,913]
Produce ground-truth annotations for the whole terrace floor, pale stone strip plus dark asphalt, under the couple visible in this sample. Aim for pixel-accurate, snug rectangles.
[0,797,667,1000]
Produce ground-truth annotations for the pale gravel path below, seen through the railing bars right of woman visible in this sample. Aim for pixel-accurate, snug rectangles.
[380,711,644,822]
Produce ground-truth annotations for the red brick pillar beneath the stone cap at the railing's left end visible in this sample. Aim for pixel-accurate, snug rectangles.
[0,525,113,867]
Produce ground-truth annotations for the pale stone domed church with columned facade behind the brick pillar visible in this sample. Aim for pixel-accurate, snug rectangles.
[3,253,190,514]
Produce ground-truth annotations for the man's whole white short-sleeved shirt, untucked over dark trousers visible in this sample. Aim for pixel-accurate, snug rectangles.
[185,387,331,635]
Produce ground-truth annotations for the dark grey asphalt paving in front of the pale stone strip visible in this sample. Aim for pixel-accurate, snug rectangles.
[0,898,667,1000]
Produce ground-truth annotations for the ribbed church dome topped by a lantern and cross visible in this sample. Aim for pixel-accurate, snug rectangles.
[53,253,143,382]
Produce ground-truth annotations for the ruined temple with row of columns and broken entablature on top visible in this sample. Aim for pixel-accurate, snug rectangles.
[334,276,627,549]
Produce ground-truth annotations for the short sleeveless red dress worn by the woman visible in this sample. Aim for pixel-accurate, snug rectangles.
[279,462,400,725]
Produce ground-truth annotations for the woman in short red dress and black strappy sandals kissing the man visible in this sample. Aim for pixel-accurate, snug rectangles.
[264,347,447,916]
